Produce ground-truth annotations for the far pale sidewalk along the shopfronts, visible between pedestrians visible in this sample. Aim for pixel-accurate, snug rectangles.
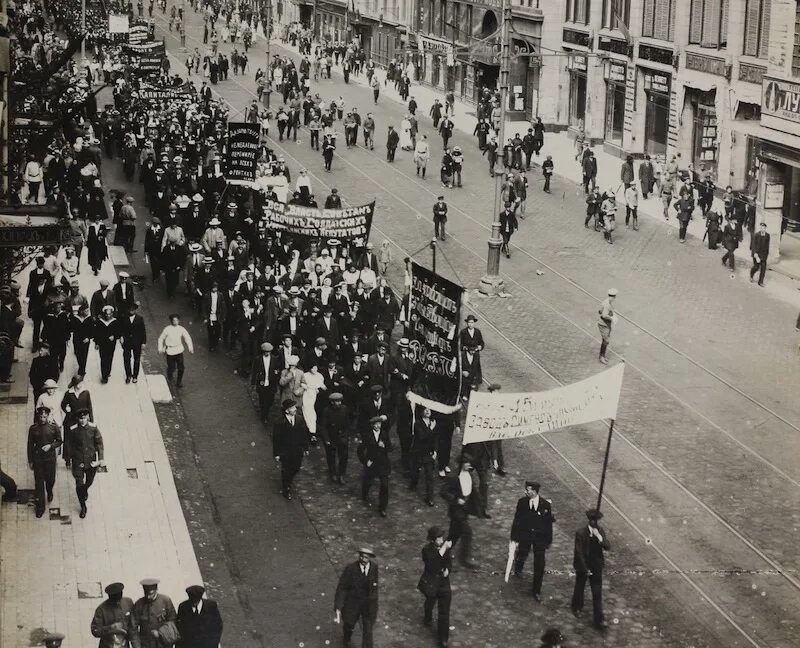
[271,38,800,280]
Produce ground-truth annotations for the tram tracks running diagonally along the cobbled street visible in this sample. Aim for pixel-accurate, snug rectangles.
[152,20,800,646]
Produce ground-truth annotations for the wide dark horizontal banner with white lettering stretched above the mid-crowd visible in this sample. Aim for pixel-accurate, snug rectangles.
[264,200,375,247]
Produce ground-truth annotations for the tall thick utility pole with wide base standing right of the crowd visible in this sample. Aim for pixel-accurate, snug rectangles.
[478,0,511,296]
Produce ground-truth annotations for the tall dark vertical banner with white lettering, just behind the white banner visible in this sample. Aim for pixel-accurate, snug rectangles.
[408,262,464,411]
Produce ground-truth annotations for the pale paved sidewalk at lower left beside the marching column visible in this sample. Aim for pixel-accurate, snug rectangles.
[0,253,202,648]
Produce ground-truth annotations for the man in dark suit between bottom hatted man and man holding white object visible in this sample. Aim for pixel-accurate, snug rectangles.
[417,527,453,648]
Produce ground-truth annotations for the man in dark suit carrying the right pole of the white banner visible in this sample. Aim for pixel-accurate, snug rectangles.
[572,509,611,630]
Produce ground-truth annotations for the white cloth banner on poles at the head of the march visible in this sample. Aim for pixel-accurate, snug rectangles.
[464,362,625,445]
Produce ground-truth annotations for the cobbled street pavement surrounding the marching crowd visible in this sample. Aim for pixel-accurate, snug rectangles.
[39,14,800,647]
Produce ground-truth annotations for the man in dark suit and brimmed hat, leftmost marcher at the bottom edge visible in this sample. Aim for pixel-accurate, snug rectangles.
[333,547,378,648]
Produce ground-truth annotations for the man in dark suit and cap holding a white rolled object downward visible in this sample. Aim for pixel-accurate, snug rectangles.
[511,481,555,602]
